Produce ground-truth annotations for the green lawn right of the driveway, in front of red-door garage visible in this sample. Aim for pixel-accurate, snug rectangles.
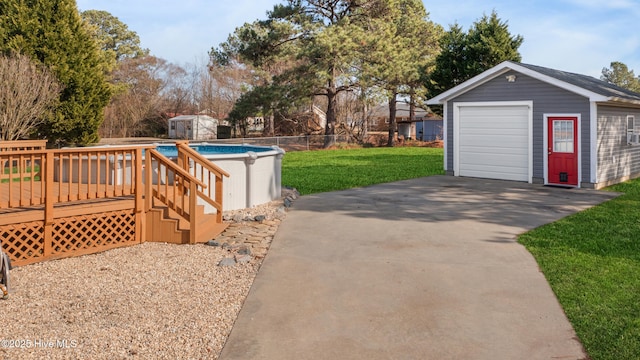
[519,179,640,360]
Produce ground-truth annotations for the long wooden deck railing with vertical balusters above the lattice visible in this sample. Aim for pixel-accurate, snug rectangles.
[0,146,143,209]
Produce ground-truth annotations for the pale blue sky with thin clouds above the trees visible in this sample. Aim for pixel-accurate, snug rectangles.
[77,0,640,77]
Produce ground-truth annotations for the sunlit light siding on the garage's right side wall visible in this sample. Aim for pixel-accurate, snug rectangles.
[597,105,640,185]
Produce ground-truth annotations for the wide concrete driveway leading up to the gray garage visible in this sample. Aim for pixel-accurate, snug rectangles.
[221,176,615,360]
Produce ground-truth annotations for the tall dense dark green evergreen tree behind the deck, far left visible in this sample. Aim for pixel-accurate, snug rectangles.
[0,0,110,145]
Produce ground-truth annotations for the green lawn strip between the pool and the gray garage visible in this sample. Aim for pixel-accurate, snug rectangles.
[282,147,444,195]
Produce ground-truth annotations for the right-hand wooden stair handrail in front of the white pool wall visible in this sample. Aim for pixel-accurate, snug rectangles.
[176,141,231,222]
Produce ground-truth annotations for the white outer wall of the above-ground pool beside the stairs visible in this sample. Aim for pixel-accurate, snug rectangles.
[190,146,285,213]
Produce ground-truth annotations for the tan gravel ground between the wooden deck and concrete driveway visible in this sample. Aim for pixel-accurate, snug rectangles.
[0,194,298,359]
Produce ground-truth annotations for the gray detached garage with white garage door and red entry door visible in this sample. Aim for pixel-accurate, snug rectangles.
[428,61,640,188]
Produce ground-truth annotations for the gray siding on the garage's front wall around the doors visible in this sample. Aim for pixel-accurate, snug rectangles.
[446,71,592,182]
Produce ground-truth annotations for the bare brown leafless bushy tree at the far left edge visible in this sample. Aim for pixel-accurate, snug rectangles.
[0,55,61,140]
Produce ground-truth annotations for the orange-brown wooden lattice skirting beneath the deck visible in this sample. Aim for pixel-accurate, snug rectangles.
[0,210,137,266]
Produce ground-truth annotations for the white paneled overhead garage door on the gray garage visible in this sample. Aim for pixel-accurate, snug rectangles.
[455,103,531,181]
